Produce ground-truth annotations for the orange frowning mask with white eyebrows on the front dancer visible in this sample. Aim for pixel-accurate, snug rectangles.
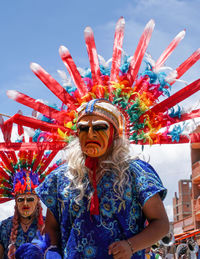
[77,115,113,157]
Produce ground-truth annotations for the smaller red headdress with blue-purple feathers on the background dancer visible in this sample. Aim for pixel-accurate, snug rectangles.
[0,117,63,203]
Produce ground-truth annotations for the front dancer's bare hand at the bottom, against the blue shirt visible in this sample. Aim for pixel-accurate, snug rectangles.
[108,240,132,259]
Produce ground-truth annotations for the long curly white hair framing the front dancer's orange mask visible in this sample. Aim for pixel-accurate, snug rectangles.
[65,137,137,203]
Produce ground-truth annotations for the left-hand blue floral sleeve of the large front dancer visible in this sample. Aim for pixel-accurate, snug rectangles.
[35,166,66,223]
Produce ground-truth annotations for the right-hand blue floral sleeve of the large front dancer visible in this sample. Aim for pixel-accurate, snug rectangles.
[131,160,167,207]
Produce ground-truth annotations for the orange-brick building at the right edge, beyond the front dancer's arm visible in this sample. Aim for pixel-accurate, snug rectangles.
[173,127,200,245]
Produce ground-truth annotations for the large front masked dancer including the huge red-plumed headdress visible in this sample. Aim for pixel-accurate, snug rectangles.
[7,17,200,259]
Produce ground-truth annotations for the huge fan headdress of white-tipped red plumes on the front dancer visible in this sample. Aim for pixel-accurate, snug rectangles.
[7,17,200,145]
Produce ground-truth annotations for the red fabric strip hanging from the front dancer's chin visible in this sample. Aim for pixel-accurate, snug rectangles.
[85,157,99,215]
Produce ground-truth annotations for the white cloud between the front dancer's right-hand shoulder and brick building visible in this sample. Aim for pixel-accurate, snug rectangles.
[132,144,191,221]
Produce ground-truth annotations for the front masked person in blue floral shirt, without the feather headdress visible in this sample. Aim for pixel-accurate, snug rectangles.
[37,100,168,258]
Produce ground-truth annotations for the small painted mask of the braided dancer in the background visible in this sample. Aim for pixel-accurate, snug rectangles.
[16,194,38,218]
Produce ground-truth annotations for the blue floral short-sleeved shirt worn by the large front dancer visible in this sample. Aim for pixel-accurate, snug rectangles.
[36,160,166,259]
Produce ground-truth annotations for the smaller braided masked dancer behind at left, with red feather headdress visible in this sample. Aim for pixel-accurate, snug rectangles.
[0,136,62,259]
